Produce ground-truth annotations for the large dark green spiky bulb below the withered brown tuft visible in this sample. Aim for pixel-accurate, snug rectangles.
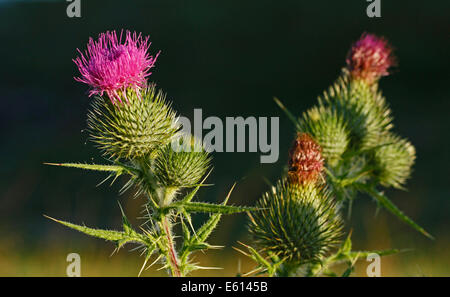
[249,181,343,264]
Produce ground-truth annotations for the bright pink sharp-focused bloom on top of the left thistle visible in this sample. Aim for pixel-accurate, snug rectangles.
[73,31,160,104]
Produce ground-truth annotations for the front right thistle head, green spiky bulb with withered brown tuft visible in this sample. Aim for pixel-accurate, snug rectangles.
[243,134,343,276]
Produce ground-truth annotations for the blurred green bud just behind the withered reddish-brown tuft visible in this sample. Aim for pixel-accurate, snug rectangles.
[297,106,349,164]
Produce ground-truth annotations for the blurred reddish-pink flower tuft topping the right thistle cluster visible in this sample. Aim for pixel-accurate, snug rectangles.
[346,33,395,84]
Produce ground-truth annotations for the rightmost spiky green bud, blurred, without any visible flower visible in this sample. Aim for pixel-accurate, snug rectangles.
[373,133,416,189]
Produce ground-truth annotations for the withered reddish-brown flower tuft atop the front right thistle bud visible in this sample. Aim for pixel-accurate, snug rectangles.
[288,133,324,184]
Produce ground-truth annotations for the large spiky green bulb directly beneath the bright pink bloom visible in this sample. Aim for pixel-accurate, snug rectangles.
[88,85,177,159]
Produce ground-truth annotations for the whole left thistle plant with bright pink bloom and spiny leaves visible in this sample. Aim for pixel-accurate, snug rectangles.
[47,31,253,276]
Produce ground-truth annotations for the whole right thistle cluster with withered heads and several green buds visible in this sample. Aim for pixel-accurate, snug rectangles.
[239,33,432,276]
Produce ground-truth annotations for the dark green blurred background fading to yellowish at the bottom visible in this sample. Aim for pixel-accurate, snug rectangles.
[0,0,450,276]
